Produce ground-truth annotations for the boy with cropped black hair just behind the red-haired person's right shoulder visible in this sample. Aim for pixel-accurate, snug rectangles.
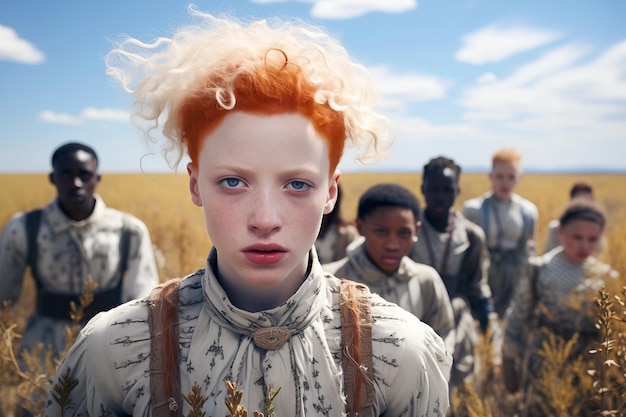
[323,183,454,352]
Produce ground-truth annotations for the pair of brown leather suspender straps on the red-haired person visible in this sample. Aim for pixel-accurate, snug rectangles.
[148,278,374,417]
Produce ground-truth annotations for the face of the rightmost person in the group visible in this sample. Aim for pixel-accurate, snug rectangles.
[557,220,602,264]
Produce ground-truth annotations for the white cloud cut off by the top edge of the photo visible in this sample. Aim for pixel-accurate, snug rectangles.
[311,0,417,19]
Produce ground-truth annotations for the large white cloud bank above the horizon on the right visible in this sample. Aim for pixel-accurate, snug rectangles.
[342,39,626,172]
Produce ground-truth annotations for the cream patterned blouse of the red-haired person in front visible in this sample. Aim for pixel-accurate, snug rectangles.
[46,251,451,417]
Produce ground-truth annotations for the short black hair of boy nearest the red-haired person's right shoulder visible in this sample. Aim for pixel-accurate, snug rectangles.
[357,183,421,221]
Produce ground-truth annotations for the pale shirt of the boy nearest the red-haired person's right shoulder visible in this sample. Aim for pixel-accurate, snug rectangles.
[323,242,455,352]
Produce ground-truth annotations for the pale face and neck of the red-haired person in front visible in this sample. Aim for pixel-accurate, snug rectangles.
[187,111,340,311]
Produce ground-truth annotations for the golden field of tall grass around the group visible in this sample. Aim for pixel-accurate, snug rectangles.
[0,173,626,417]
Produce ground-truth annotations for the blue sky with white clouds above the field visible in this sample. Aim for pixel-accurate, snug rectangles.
[0,0,626,172]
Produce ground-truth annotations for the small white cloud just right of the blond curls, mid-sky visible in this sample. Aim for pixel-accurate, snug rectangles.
[369,66,451,110]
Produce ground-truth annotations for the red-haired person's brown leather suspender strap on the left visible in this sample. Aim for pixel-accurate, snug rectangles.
[148,278,183,417]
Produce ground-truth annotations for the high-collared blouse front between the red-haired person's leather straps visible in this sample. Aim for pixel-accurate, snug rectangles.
[191,250,344,416]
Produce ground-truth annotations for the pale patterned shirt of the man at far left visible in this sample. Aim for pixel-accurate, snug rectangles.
[0,196,159,352]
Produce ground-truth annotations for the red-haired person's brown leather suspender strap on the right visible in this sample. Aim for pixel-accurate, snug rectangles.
[340,279,374,417]
